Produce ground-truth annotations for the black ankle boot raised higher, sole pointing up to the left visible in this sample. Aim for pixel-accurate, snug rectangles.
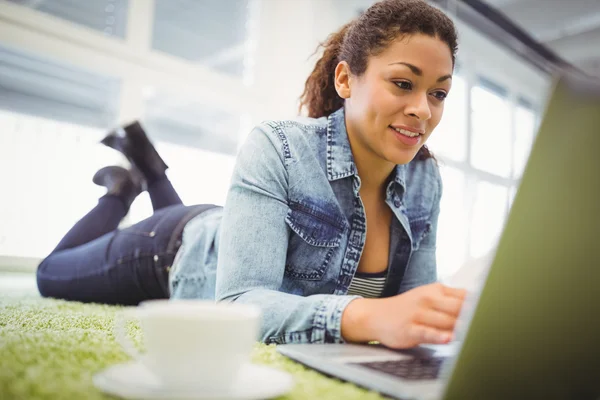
[101,121,169,185]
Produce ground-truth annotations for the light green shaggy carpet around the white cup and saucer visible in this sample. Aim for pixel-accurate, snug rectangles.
[0,295,383,400]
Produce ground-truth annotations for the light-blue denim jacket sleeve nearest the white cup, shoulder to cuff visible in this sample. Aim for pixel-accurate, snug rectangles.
[215,123,356,344]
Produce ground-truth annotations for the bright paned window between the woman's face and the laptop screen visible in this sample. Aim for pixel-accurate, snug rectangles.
[428,74,537,280]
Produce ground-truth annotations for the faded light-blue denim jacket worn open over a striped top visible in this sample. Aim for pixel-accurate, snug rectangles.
[170,109,442,344]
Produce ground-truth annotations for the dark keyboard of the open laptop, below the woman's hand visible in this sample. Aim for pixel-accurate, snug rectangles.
[356,357,446,381]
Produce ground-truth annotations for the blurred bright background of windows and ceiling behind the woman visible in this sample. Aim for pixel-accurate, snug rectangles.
[0,0,600,286]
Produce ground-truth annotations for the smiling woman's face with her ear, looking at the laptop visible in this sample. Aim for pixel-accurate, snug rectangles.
[336,34,453,164]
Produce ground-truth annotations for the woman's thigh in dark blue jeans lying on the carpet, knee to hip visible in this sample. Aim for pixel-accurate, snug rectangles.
[37,205,195,305]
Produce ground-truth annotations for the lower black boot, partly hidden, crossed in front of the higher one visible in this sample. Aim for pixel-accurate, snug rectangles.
[92,166,145,209]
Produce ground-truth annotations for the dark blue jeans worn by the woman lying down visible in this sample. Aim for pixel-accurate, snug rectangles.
[37,179,212,305]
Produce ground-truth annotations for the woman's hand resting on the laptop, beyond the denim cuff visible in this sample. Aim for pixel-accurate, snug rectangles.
[342,283,466,349]
